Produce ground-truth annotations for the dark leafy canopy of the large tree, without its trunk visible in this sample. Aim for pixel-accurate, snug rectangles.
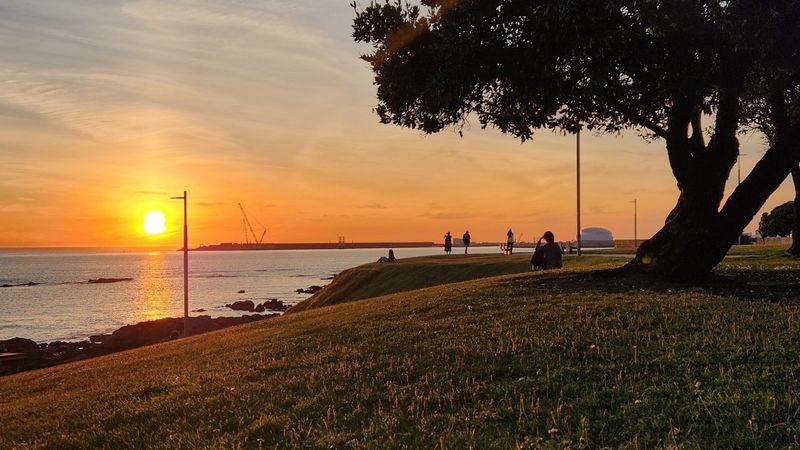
[354,0,800,140]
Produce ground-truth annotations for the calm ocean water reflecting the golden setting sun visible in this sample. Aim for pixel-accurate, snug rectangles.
[0,247,512,342]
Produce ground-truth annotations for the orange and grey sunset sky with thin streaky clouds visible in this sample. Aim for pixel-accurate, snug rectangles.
[0,0,792,247]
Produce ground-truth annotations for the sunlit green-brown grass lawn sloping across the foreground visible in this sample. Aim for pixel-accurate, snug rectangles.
[0,249,800,448]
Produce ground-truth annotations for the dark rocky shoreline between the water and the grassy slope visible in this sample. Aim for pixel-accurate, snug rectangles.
[0,313,280,376]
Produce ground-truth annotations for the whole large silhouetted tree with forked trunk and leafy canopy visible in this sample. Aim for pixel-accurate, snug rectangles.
[353,0,800,276]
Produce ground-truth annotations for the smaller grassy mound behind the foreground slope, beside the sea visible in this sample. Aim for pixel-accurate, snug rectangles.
[289,254,530,313]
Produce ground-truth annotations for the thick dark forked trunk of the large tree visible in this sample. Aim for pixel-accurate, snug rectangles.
[623,132,800,278]
